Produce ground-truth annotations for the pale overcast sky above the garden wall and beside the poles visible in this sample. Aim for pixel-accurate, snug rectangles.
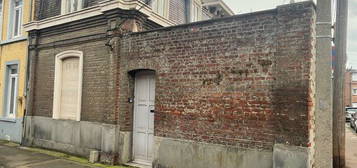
[223,0,357,69]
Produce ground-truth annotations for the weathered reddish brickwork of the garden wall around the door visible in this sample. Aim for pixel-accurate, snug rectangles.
[118,2,315,149]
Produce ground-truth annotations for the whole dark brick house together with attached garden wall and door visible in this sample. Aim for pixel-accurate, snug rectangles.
[24,0,320,168]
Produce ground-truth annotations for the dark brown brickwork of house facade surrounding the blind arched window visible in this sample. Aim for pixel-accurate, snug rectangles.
[29,10,158,124]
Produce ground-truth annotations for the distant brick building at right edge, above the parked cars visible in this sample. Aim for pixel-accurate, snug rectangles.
[345,69,357,107]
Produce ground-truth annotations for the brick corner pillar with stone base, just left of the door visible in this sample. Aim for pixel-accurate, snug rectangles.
[106,10,147,163]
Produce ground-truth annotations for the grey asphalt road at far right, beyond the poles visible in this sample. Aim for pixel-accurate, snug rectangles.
[346,123,357,168]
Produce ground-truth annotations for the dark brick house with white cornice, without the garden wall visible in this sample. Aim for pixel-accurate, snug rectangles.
[24,0,232,165]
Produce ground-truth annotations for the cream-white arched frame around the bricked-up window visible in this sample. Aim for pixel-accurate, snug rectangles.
[52,50,83,121]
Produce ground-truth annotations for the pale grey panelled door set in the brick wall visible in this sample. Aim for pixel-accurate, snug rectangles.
[133,72,155,164]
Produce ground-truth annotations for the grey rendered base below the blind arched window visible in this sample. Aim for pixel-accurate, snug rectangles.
[25,116,119,163]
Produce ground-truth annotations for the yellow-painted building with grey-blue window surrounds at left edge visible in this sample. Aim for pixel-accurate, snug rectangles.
[0,0,31,142]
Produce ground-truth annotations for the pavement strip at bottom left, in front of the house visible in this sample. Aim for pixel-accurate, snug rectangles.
[0,141,126,168]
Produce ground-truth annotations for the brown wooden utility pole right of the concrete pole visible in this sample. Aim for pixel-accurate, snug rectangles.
[333,0,348,167]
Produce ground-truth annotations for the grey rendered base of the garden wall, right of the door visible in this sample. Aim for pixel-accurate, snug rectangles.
[153,137,273,168]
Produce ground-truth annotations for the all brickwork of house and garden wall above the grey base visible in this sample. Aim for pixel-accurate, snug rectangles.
[30,2,315,154]
